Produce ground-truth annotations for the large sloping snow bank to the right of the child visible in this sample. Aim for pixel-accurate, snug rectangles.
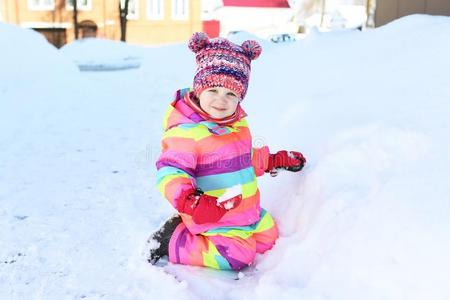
[246,15,450,299]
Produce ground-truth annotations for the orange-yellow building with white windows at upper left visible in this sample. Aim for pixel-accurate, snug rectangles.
[0,0,202,47]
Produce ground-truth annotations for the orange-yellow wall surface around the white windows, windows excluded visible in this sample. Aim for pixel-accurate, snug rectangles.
[1,0,202,44]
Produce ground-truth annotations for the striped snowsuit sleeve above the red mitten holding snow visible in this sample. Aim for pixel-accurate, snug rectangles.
[156,127,197,208]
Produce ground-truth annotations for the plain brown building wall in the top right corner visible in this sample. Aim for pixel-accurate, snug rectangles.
[375,0,450,27]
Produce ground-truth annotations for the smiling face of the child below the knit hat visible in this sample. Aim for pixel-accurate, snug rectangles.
[199,87,240,119]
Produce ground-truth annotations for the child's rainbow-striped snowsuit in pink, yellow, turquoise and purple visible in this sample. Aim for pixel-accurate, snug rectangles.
[156,89,278,270]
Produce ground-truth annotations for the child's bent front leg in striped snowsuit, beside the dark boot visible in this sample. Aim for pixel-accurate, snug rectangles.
[169,223,256,270]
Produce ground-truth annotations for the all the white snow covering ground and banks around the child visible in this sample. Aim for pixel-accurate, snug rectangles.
[0,15,450,299]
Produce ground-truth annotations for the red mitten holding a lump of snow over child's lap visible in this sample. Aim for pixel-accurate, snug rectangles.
[176,189,227,224]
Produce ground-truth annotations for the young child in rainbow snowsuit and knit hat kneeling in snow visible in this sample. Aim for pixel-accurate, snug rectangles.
[148,33,306,270]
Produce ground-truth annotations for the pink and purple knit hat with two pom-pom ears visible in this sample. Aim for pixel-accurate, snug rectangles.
[189,32,262,99]
